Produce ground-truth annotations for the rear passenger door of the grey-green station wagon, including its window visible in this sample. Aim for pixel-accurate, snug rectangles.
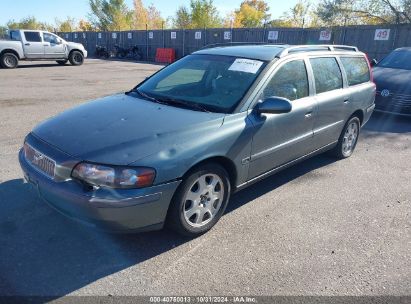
[309,56,350,149]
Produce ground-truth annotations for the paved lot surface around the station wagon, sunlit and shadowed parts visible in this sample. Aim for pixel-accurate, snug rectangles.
[0,60,411,297]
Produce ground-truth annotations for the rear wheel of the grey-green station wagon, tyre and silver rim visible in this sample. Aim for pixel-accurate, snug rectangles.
[330,116,361,159]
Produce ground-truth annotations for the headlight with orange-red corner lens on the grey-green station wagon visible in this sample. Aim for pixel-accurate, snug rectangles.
[71,163,156,189]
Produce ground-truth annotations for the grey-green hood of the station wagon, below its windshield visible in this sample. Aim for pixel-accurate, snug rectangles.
[33,94,225,165]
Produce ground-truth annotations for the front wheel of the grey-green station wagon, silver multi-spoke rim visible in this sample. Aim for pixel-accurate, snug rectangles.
[167,163,230,237]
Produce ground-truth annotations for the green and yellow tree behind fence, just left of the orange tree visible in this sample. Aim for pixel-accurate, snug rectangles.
[89,0,133,31]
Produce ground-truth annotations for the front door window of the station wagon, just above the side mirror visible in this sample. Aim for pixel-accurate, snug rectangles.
[260,60,308,100]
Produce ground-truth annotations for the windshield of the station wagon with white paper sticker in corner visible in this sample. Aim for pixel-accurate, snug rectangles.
[136,54,266,113]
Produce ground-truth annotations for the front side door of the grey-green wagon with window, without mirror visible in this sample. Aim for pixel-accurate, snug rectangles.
[249,59,316,179]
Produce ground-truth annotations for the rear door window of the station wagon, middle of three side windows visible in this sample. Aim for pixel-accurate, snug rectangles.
[310,57,342,94]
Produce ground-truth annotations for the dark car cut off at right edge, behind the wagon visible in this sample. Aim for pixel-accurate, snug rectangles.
[373,47,411,116]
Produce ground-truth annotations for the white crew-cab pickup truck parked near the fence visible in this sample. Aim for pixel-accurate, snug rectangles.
[0,30,87,69]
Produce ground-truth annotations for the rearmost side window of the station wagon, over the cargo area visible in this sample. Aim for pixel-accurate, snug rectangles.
[340,57,370,86]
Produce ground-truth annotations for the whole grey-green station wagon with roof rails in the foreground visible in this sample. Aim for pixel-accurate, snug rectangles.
[19,45,375,236]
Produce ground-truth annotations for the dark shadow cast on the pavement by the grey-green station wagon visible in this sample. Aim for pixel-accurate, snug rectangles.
[0,155,335,297]
